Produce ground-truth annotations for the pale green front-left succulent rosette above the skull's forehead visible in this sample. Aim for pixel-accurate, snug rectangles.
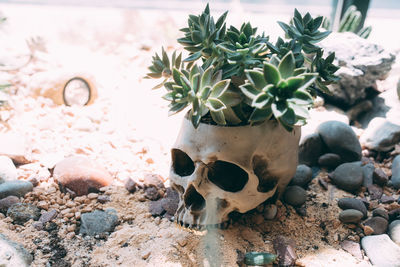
[163,65,241,128]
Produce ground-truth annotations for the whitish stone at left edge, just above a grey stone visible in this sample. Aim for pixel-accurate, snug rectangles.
[0,133,32,164]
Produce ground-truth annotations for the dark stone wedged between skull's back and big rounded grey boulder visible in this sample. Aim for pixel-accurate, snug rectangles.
[299,133,323,166]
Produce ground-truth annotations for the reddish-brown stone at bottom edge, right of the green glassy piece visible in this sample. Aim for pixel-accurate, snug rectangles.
[272,236,297,266]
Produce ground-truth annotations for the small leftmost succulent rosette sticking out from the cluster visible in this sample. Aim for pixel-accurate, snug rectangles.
[145,48,182,89]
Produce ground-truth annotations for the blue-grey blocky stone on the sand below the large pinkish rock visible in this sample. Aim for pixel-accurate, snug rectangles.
[79,209,118,236]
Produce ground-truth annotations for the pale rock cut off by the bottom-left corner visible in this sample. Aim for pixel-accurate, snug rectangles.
[0,234,33,267]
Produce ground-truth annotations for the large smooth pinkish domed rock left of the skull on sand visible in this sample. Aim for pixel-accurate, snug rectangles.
[53,156,113,196]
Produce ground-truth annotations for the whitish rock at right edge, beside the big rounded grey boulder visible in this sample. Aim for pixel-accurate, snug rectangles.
[360,117,400,151]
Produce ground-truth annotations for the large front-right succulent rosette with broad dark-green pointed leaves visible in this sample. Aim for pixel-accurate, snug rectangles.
[240,52,318,131]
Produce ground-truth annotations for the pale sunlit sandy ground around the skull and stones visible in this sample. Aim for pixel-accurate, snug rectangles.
[0,4,398,266]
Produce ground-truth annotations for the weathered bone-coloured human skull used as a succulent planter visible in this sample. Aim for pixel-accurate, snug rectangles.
[170,118,300,228]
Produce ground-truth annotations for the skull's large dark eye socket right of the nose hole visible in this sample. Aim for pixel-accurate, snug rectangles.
[208,160,249,192]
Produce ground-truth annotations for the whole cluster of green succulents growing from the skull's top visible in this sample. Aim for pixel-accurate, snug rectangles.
[146,5,338,131]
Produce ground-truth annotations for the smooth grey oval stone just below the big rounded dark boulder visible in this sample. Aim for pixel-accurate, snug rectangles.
[331,161,363,192]
